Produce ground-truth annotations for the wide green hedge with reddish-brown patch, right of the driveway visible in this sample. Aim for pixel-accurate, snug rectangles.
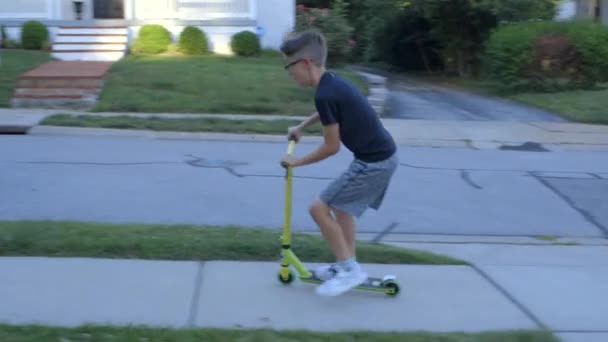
[484,21,608,92]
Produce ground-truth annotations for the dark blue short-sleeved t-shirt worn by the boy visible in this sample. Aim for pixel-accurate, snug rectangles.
[315,72,396,162]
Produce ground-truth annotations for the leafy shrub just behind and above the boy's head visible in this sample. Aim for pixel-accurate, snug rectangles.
[295,0,354,65]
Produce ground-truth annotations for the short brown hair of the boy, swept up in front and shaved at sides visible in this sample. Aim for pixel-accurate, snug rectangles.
[281,30,327,67]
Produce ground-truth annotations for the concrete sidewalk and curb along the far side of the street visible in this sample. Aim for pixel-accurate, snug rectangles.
[0,109,608,151]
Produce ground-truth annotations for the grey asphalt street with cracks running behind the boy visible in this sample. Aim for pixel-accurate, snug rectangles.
[0,135,608,238]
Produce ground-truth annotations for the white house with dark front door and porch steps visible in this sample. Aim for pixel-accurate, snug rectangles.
[0,0,295,60]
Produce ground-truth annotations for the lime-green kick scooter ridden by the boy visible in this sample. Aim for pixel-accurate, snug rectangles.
[278,140,399,296]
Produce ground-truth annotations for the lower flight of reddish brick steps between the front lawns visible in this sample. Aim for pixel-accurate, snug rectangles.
[11,61,111,109]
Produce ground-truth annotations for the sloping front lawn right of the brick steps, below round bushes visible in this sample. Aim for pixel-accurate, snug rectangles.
[93,54,367,115]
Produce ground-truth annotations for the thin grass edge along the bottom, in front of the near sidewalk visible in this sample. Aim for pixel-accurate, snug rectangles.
[0,325,558,342]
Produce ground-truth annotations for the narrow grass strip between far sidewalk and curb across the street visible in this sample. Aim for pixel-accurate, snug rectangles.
[40,114,322,135]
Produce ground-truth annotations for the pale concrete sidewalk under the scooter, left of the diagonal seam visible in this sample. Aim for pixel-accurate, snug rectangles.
[0,258,552,332]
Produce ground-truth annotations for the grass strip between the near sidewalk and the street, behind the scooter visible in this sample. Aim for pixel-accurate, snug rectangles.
[0,221,466,265]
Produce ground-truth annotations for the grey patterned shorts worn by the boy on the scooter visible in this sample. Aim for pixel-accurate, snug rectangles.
[320,153,399,218]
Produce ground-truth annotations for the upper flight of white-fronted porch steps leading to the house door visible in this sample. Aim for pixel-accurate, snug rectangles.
[51,26,128,61]
